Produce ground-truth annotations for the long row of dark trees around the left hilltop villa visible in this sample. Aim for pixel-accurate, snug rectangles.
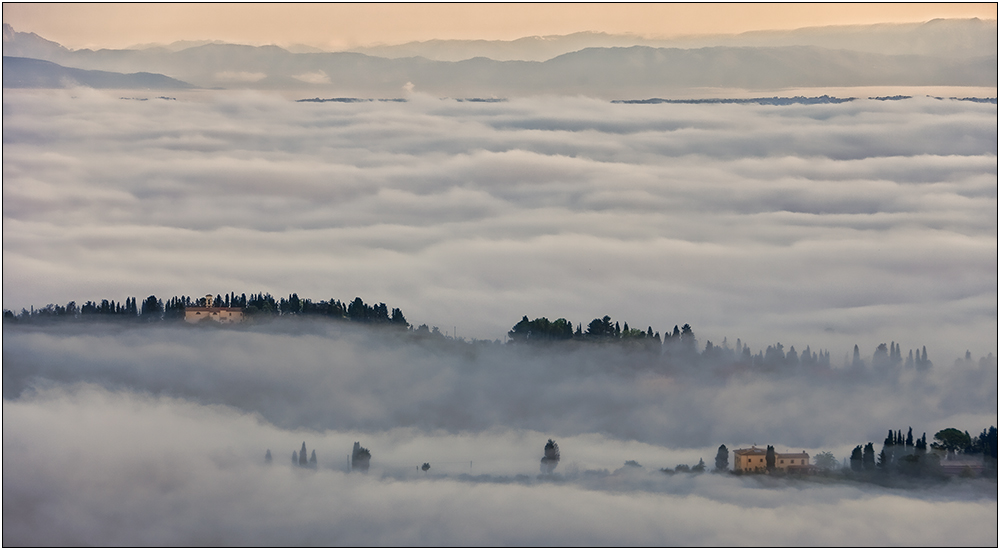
[3,292,409,327]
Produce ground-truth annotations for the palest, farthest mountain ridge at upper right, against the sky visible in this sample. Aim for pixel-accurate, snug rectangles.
[348,19,997,61]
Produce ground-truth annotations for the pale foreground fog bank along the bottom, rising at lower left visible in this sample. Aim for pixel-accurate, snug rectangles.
[3,386,997,546]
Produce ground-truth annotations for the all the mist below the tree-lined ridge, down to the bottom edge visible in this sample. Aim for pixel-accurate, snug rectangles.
[3,319,997,546]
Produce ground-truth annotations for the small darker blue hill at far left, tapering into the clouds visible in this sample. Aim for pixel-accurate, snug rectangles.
[3,55,193,90]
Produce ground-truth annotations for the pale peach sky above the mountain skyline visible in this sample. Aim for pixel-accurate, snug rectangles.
[3,3,997,49]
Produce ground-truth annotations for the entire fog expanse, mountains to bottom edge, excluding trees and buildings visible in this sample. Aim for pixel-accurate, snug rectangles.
[3,89,998,546]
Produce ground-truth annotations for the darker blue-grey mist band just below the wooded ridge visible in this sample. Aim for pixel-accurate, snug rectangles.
[3,322,997,452]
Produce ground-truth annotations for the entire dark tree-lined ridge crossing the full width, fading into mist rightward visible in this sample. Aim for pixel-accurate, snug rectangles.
[3,292,997,372]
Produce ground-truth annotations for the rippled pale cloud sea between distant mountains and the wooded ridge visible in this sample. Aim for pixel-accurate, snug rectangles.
[3,90,997,365]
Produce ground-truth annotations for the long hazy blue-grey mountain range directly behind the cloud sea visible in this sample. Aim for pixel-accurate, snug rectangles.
[4,20,997,99]
